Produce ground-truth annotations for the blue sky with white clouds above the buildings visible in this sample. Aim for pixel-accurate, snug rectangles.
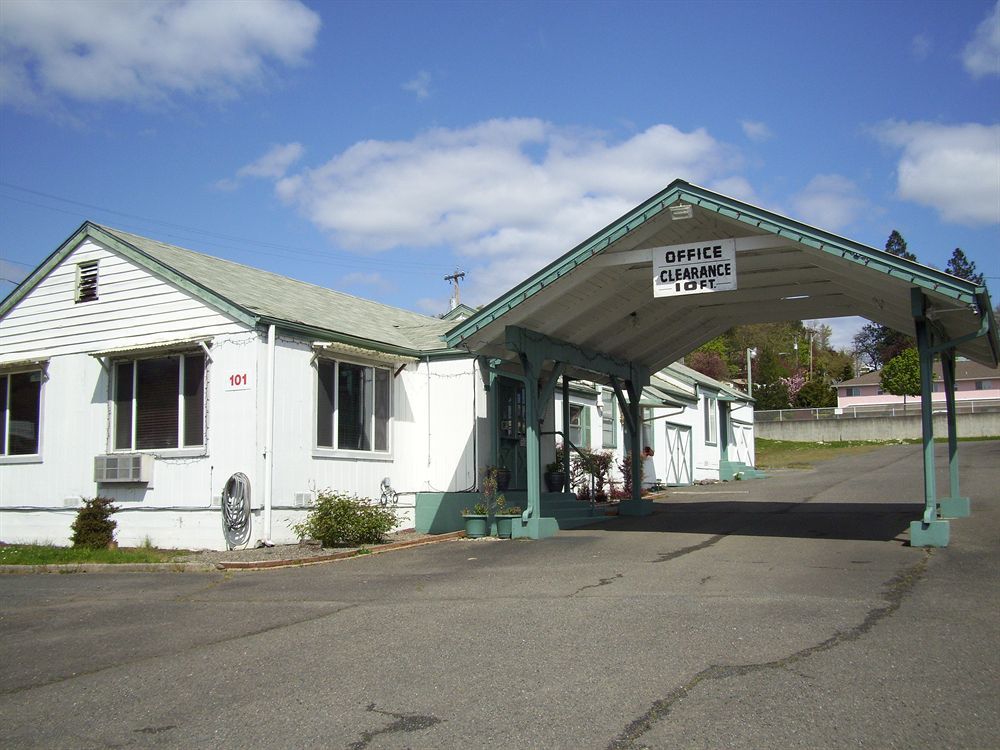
[0,0,1000,350]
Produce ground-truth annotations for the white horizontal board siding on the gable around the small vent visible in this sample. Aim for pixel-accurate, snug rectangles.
[0,239,243,363]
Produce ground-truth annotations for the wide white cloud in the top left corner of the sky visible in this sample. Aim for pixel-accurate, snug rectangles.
[0,0,320,109]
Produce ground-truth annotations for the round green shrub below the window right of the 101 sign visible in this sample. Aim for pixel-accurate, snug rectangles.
[291,490,396,547]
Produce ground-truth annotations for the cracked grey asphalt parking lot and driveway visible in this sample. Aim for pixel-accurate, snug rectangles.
[0,442,1000,750]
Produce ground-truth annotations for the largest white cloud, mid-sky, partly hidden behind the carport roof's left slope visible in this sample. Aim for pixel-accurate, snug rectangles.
[277,119,752,303]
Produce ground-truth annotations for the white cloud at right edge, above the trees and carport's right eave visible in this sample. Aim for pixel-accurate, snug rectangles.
[875,122,1000,225]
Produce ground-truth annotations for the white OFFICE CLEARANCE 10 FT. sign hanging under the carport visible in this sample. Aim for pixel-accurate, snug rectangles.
[653,240,736,297]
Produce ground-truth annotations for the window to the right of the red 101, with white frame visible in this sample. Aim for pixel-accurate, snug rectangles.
[316,359,392,452]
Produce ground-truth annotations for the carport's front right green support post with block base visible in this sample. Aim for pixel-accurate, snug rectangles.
[910,288,949,547]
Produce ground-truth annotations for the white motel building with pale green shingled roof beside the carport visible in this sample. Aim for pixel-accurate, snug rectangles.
[0,222,753,548]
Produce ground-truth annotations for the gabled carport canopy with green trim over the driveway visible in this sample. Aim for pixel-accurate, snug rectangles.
[446,180,1000,543]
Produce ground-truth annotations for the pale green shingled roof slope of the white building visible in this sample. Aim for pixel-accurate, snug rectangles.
[91,224,454,353]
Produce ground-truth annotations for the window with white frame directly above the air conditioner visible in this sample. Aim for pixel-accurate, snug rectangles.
[112,353,205,451]
